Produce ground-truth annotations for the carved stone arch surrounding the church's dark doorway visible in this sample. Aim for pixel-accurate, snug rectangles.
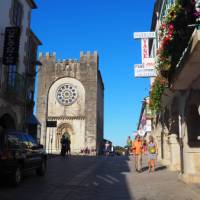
[56,123,74,150]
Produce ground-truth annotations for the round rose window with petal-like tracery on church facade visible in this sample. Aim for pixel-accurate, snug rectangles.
[57,83,78,106]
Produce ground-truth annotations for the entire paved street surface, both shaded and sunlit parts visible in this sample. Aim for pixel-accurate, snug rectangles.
[0,156,200,200]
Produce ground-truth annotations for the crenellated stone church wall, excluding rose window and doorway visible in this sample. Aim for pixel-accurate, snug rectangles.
[37,52,104,153]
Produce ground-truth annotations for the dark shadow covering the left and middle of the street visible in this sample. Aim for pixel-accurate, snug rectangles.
[0,155,134,200]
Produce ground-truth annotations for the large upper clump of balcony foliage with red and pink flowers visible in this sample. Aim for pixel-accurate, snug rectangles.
[156,0,194,78]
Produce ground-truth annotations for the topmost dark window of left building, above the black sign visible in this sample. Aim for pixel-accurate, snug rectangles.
[12,0,23,26]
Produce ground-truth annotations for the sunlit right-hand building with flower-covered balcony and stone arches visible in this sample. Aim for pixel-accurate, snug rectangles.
[150,0,200,182]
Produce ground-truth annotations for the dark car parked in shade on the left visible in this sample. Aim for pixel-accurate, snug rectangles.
[0,132,47,186]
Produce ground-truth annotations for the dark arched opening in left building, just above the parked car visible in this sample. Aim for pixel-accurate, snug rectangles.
[0,113,16,130]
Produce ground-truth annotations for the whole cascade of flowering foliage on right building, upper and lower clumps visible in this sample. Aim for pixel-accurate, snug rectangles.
[150,0,195,112]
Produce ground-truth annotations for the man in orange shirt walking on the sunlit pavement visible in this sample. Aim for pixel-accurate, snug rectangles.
[132,135,143,172]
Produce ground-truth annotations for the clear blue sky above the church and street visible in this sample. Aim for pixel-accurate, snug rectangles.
[31,0,154,146]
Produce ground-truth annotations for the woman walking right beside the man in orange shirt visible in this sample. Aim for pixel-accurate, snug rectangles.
[148,135,158,172]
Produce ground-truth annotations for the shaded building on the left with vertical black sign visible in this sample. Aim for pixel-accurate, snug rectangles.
[0,0,41,138]
